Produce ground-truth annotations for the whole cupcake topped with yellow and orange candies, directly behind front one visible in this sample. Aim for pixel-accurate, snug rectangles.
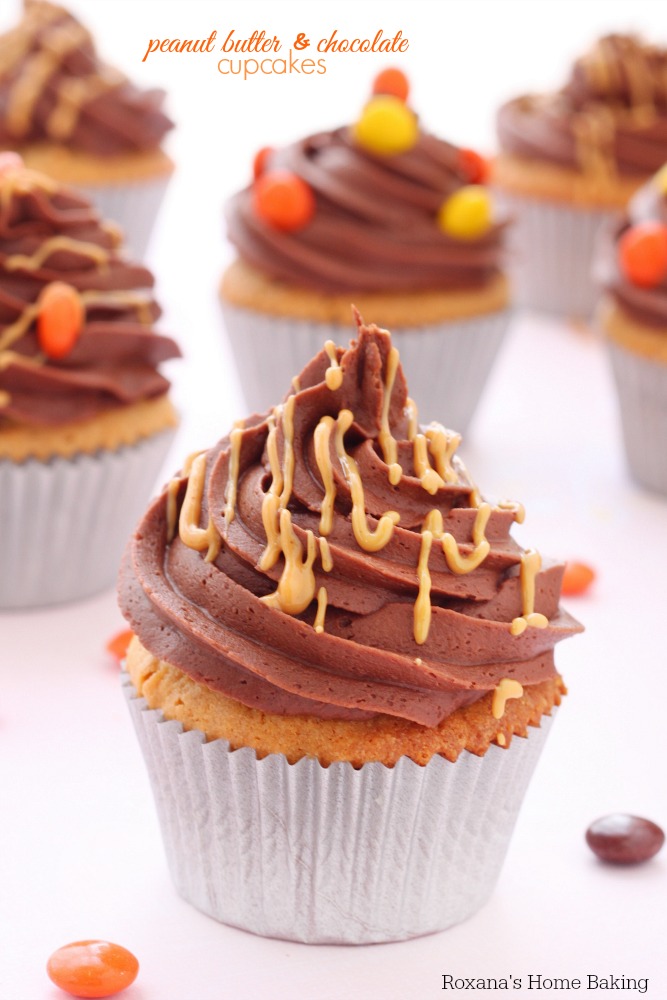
[221,71,510,429]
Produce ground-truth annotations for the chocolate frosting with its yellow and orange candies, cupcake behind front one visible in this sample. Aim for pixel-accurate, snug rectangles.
[226,75,505,295]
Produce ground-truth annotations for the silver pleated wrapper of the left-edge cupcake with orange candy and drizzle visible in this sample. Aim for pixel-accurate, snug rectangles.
[0,429,175,609]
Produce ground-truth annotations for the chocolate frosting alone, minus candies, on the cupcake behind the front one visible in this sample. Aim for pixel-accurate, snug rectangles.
[226,128,504,293]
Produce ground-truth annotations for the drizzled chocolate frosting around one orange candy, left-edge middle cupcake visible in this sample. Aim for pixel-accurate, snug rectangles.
[0,154,180,428]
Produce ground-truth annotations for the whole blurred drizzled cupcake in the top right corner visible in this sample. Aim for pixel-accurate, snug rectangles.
[494,35,667,319]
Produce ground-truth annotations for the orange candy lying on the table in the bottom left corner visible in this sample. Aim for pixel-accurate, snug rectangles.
[46,941,139,997]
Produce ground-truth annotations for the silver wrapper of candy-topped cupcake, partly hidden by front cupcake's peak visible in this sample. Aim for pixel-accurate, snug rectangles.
[223,303,512,432]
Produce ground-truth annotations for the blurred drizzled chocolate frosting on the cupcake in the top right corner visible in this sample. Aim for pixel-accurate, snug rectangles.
[497,35,667,175]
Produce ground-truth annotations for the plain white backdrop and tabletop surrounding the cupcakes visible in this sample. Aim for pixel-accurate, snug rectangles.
[0,0,667,1000]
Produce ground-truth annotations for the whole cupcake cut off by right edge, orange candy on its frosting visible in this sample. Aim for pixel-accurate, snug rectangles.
[596,167,667,495]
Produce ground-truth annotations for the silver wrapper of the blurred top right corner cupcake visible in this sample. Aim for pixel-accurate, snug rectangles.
[496,191,618,321]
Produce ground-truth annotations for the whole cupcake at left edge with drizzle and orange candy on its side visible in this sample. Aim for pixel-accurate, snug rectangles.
[0,153,179,608]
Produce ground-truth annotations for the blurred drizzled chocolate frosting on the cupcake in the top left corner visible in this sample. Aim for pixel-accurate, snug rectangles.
[0,0,173,156]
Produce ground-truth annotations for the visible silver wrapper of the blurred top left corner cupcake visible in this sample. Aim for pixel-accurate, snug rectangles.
[72,174,171,260]
